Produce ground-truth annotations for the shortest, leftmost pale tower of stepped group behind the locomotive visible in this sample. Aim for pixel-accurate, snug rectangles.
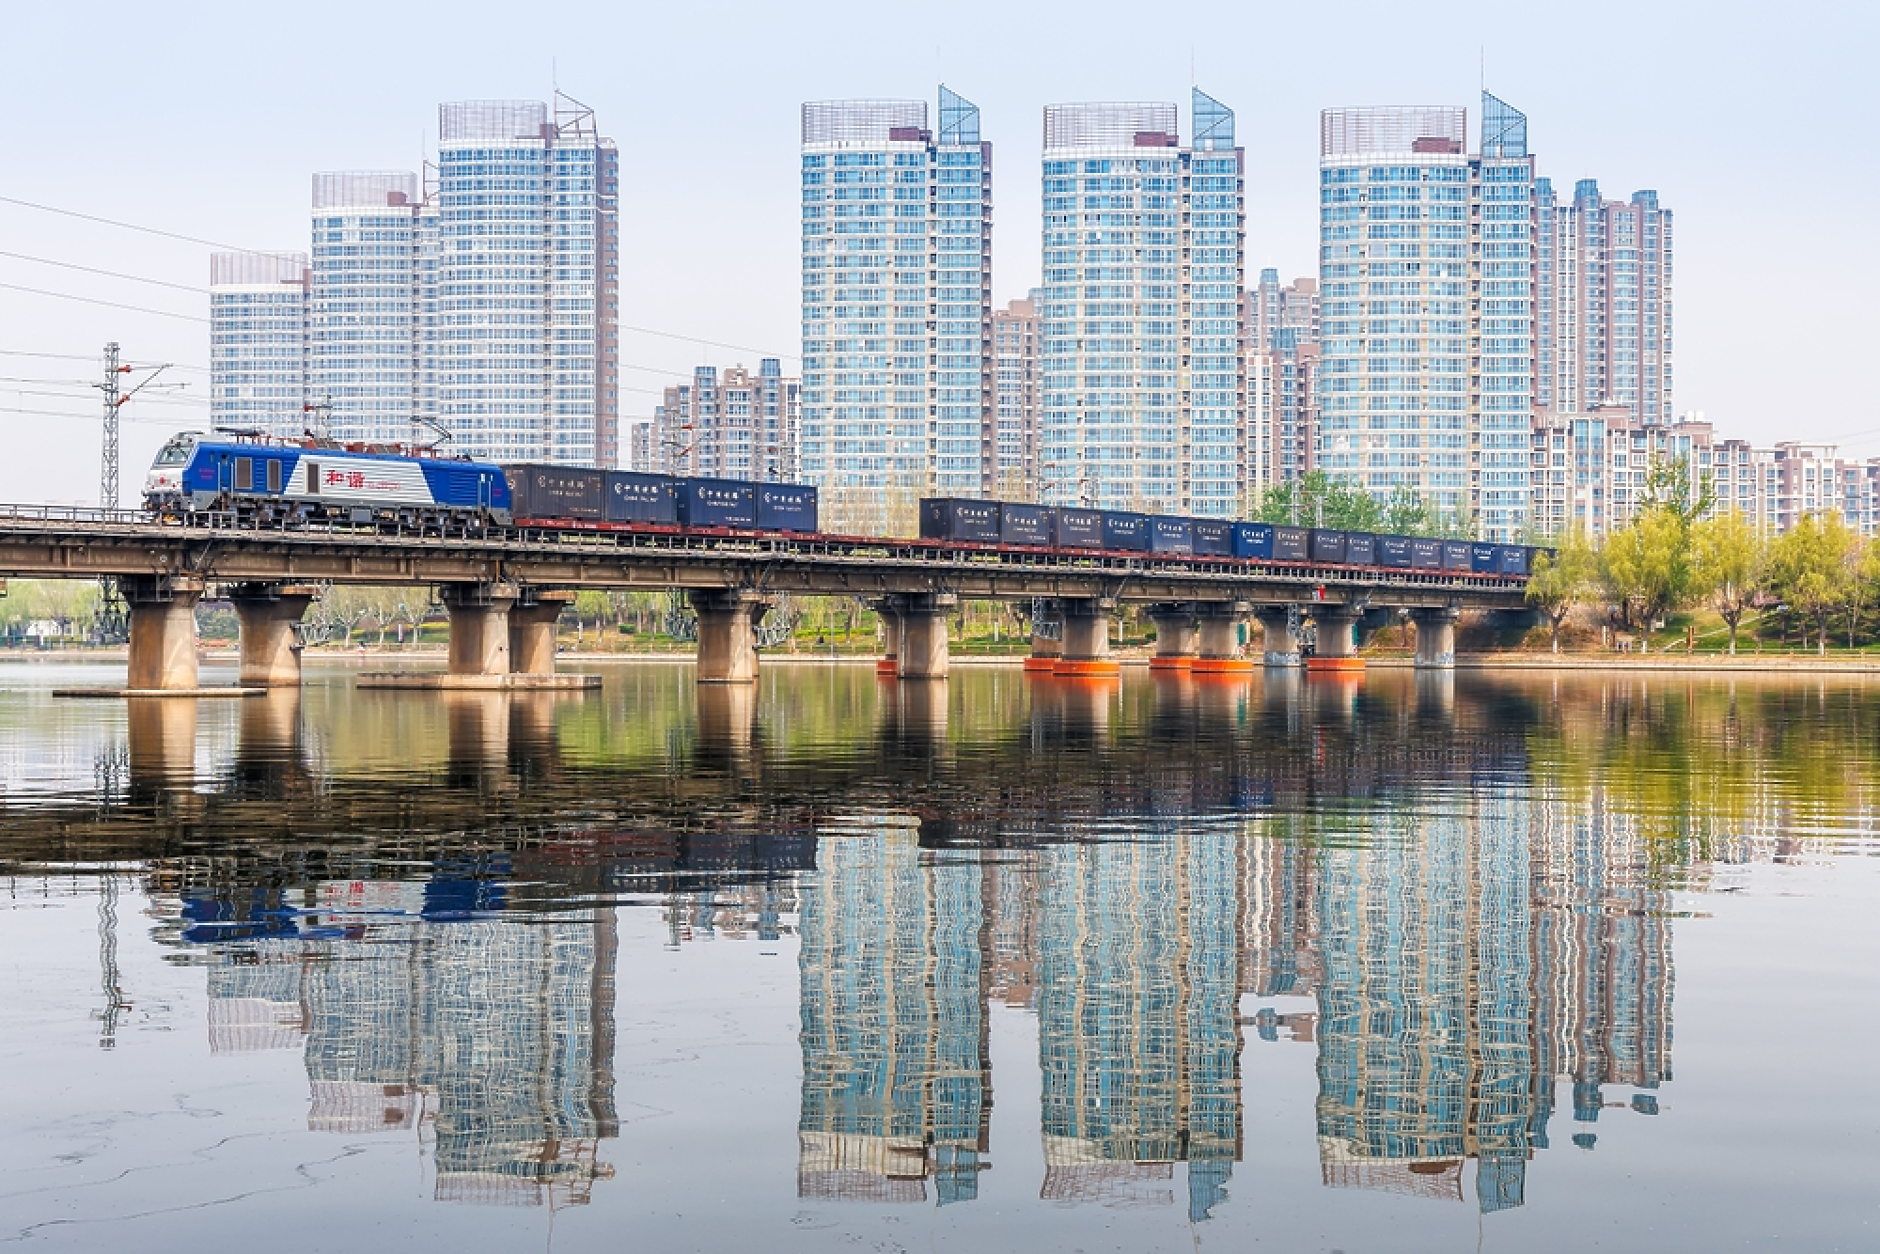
[209,252,308,436]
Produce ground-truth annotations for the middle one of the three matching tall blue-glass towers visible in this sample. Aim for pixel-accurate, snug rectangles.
[1038,90,1246,517]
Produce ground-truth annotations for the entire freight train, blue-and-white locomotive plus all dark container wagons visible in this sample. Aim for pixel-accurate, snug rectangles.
[145,432,1538,579]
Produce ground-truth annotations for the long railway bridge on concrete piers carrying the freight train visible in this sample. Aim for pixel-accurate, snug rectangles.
[0,506,1525,692]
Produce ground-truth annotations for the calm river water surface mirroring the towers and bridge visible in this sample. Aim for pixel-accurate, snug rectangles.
[0,662,1880,1254]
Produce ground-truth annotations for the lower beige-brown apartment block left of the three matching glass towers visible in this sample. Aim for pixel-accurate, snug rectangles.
[650,357,797,483]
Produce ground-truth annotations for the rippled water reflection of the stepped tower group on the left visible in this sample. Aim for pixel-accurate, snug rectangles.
[209,880,619,1205]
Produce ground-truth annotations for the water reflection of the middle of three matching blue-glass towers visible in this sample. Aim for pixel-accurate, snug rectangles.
[1038,827,1241,1220]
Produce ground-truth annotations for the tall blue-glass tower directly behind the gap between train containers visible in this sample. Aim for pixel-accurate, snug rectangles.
[799,86,996,525]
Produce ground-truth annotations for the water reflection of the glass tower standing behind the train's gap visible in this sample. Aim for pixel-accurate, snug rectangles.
[797,820,993,1205]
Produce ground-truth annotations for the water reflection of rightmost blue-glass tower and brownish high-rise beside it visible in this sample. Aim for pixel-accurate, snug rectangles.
[1300,780,1671,1211]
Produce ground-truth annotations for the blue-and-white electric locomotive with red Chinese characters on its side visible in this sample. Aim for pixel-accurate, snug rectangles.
[143,432,511,528]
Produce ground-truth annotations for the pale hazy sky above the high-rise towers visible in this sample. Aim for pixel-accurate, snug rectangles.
[0,0,1880,502]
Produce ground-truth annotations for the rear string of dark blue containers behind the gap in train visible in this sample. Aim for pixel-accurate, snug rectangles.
[921,496,1543,579]
